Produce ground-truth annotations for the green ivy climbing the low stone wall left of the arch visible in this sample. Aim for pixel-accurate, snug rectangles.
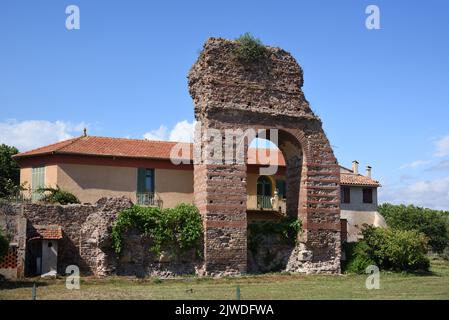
[112,203,203,255]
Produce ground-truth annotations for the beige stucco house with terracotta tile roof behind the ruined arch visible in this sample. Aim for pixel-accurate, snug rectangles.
[14,135,385,241]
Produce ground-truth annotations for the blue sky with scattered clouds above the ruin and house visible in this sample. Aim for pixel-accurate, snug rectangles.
[0,0,449,209]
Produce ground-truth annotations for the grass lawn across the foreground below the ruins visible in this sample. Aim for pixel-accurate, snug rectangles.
[0,260,449,300]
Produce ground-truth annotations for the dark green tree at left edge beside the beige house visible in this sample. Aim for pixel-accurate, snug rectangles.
[0,144,20,198]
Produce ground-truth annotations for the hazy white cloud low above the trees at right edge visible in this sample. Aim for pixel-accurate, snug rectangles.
[379,176,449,210]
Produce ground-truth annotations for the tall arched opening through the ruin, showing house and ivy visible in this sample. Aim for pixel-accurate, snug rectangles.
[247,130,303,273]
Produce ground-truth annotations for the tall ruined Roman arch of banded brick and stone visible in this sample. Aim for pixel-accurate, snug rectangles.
[189,38,340,275]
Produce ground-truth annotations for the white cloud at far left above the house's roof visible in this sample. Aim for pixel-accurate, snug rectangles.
[0,120,87,152]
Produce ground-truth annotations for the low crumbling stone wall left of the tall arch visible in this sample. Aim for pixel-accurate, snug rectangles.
[0,197,203,277]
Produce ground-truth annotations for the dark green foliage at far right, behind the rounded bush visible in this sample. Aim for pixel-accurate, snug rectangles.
[378,203,449,253]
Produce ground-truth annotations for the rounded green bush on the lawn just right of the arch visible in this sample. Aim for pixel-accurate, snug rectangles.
[343,226,430,273]
